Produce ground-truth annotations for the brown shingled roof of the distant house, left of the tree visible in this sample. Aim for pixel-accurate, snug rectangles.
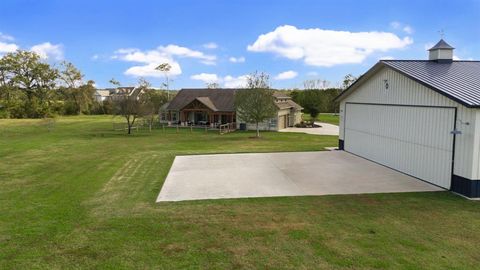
[167,88,236,112]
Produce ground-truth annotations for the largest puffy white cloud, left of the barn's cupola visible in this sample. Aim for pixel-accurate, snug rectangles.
[247,25,413,67]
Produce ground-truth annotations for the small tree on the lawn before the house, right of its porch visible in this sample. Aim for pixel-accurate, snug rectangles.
[235,72,277,138]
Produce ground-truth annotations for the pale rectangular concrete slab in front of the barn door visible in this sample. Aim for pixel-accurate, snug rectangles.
[157,151,443,202]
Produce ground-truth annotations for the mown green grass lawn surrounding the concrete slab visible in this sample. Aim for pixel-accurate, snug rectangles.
[0,117,480,269]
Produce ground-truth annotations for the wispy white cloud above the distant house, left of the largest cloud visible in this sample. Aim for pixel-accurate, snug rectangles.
[111,44,216,77]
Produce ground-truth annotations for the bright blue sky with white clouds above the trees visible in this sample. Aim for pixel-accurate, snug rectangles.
[0,0,480,88]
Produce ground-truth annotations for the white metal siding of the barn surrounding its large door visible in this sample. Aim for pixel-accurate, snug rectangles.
[339,67,480,182]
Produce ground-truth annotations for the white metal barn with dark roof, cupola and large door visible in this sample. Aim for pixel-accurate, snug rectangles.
[336,40,480,198]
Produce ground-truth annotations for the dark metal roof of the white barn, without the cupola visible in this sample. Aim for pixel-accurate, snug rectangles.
[335,60,480,108]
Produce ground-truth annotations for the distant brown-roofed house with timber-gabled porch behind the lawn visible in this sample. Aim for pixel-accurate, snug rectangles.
[160,88,302,130]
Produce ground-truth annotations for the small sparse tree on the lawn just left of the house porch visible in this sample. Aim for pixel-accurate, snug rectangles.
[110,79,147,135]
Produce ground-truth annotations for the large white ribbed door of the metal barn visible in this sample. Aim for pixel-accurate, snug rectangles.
[344,103,455,189]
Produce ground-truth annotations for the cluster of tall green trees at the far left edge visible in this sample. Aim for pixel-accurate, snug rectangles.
[0,50,103,118]
